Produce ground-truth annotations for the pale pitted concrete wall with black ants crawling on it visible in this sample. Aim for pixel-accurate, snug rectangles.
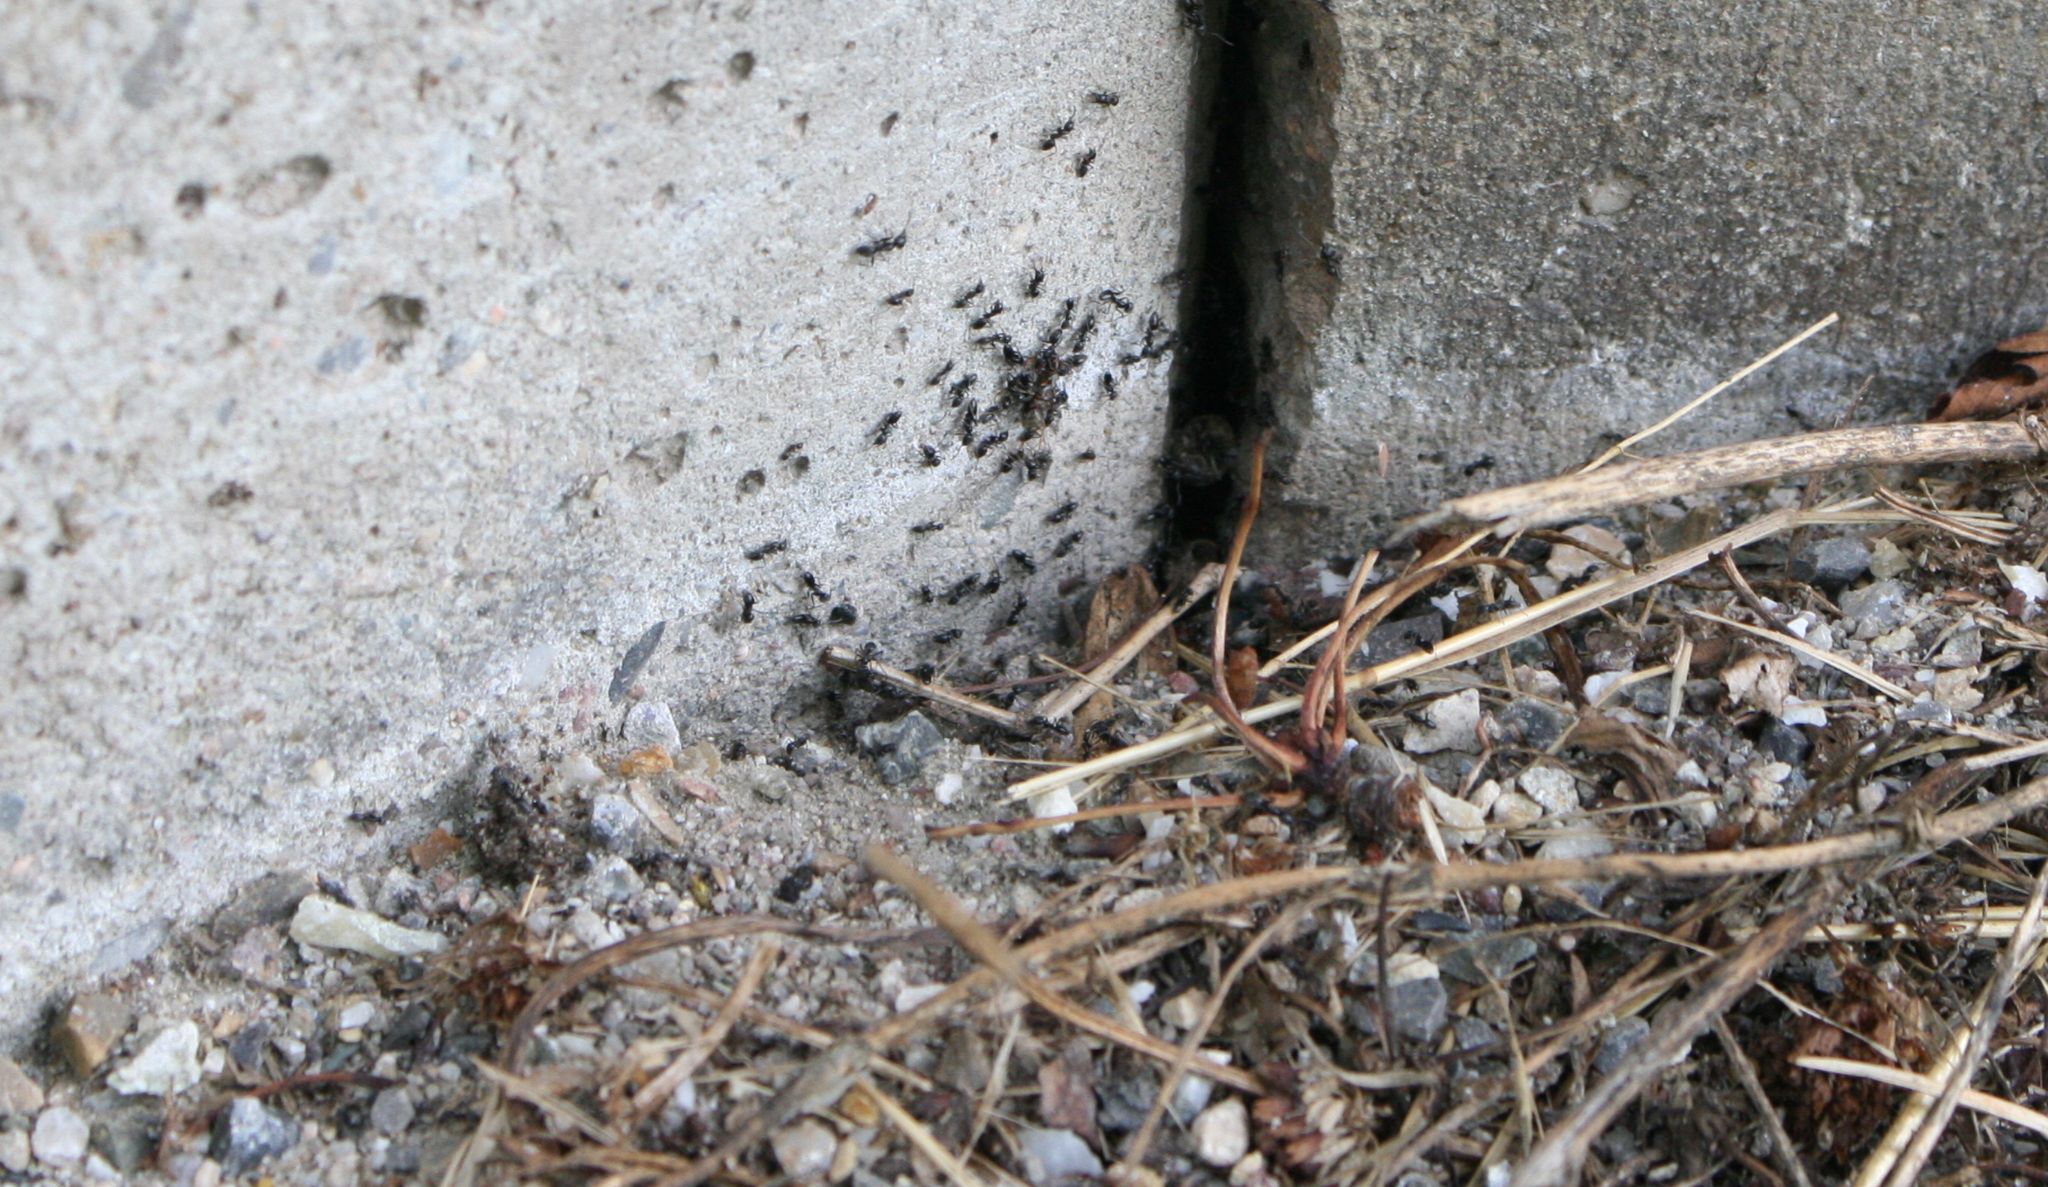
[0,0,1194,1031]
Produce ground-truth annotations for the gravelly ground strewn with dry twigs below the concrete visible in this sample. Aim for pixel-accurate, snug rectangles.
[12,413,2048,1187]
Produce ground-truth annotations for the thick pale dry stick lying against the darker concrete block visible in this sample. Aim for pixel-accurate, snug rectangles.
[1403,420,2042,536]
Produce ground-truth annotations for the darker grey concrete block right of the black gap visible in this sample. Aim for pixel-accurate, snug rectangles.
[1233,0,2048,557]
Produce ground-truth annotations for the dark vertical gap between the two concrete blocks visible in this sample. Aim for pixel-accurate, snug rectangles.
[1161,0,1341,567]
